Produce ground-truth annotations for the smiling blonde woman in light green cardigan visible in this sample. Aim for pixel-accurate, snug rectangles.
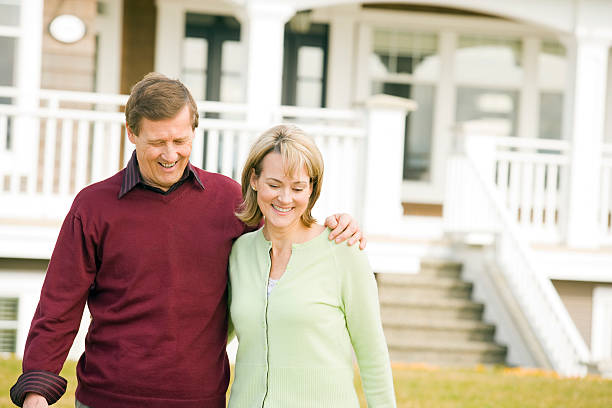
[229,125,395,408]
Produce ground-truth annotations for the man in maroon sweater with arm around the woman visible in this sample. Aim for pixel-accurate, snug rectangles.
[11,74,365,408]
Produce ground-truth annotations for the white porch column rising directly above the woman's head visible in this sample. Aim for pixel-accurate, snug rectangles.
[241,0,295,126]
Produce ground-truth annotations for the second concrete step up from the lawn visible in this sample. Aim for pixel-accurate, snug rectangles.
[383,319,495,345]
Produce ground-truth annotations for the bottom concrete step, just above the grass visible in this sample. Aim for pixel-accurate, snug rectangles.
[389,341,507,366]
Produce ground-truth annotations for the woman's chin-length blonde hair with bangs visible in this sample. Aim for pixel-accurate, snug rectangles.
[236,125,323,227]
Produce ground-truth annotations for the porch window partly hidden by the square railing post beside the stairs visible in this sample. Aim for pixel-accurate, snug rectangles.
[369,29,440,181]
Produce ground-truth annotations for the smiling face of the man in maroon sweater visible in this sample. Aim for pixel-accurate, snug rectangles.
[128,105,194,191]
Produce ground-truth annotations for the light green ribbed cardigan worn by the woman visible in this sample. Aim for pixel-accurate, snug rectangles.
[229,229,396,408]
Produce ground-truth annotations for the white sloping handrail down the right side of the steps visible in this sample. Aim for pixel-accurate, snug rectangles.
[445,135,591,376]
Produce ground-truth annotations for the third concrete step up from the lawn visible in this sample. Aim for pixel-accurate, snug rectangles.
[380,298,484,324]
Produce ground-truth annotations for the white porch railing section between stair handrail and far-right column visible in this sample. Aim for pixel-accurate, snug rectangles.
[448,134,570,243]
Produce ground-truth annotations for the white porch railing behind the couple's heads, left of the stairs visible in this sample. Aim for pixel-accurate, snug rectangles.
[0,87,366,225]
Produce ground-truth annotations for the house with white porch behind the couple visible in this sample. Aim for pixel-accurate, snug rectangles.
[0,0,612,375]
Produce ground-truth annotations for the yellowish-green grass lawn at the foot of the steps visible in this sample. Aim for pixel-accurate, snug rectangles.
[0,357,612,408]
